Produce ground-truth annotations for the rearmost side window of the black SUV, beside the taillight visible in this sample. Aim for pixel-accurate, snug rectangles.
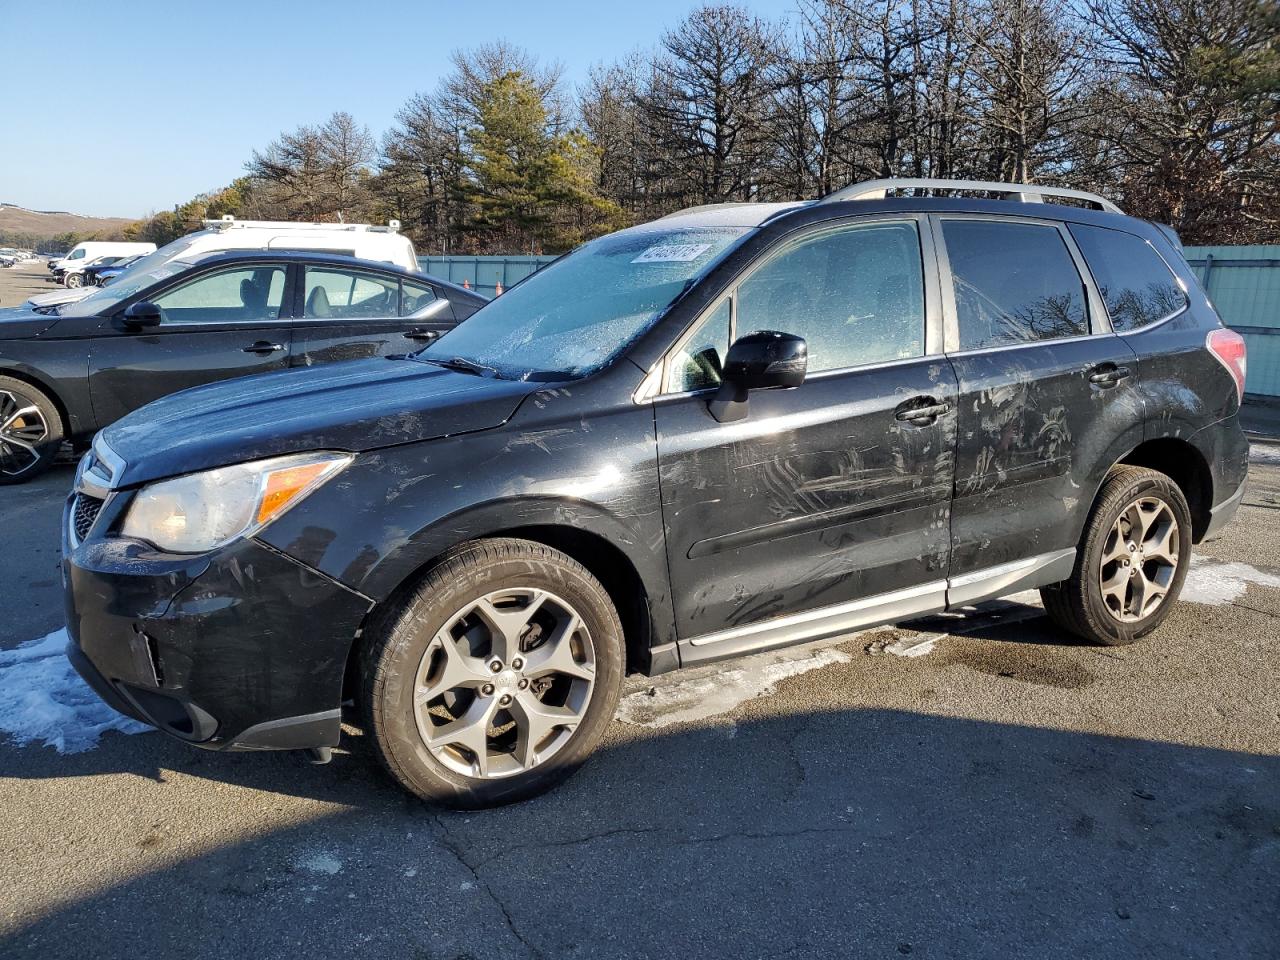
[1070,224,1187,332]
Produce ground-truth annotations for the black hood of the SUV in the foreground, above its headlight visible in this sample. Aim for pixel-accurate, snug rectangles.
[101,357,535,485]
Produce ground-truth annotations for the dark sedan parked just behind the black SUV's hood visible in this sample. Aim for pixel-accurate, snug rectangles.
[0,251,485,484]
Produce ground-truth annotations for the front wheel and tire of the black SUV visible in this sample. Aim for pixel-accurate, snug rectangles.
[360,539,625,809]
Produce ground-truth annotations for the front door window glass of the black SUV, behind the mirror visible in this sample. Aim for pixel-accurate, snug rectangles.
[737,223,924,372]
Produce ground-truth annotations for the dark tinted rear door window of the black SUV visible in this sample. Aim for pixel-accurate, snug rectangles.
[942,220,1089,349]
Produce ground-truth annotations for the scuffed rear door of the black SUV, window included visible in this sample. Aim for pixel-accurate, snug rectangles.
[933,215,1143,604]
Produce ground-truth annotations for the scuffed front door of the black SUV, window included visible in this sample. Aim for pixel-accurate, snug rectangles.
[654,218,956,662]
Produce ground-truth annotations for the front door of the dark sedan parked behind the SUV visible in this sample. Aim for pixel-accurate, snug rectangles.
[88,262,291,428]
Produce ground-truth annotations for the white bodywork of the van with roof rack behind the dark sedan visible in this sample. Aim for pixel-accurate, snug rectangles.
[27,216,419,307]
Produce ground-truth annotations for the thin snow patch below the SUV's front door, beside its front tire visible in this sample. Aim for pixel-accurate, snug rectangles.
[617,647,852,730]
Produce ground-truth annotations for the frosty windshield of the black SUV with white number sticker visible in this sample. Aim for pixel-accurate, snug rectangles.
[415,227,748,380]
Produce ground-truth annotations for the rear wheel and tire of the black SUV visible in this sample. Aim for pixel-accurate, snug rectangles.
[1041,466,1192,646]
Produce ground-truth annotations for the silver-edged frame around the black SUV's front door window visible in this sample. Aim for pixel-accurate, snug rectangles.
[632,214,945,403]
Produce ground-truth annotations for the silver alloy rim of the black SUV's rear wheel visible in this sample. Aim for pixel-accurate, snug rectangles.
[1098,497,1179,623]
